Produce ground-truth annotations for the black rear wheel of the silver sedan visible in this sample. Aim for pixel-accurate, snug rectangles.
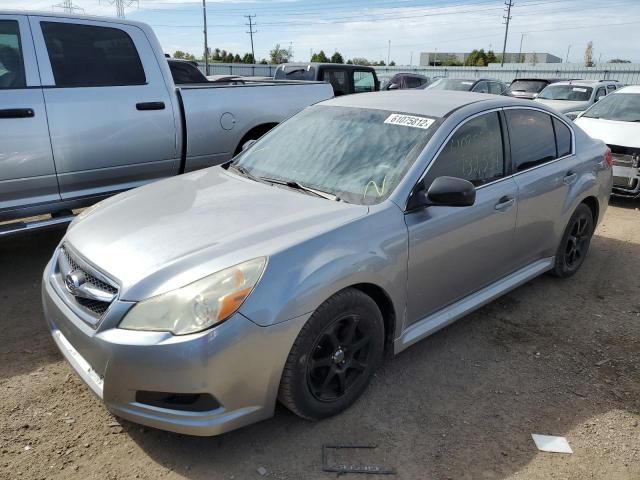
[551,203,595,278]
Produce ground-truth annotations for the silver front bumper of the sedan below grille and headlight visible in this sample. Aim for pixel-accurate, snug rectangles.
[42,260,308,435]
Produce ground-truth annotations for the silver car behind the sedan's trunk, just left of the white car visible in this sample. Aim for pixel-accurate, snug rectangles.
[535,80,623,120]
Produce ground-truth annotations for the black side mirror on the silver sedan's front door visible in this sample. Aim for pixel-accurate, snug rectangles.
[407,177,476,210]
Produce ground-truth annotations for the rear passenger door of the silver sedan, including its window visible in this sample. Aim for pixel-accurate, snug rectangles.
[505,108,584,265]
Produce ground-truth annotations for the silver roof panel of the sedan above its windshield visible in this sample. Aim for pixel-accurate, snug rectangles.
[322,90,520,117]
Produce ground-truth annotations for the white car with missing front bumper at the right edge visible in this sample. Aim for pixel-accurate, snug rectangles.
[575,85,640,198]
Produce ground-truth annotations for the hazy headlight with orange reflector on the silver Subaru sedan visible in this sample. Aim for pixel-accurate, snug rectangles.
[119,257,267,335]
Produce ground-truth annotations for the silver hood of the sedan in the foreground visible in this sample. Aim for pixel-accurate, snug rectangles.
[64,167,368,300]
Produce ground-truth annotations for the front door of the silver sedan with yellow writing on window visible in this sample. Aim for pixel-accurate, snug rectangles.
[405,111,517,325]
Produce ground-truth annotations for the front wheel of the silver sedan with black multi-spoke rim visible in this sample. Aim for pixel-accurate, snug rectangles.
[278,288,384,420]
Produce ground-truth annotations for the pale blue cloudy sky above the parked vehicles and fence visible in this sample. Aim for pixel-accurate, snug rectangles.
[5,0,640,65]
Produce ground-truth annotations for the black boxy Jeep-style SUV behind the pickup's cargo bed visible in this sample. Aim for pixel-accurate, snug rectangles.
[273,63,380,97]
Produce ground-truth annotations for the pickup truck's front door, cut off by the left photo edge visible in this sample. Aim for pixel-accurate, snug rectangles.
[0,15,60,213]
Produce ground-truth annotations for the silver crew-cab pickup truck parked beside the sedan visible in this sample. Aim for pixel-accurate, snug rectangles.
[0,10,333,235]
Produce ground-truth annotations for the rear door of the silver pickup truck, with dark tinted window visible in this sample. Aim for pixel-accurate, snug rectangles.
[30,17,179,199]
